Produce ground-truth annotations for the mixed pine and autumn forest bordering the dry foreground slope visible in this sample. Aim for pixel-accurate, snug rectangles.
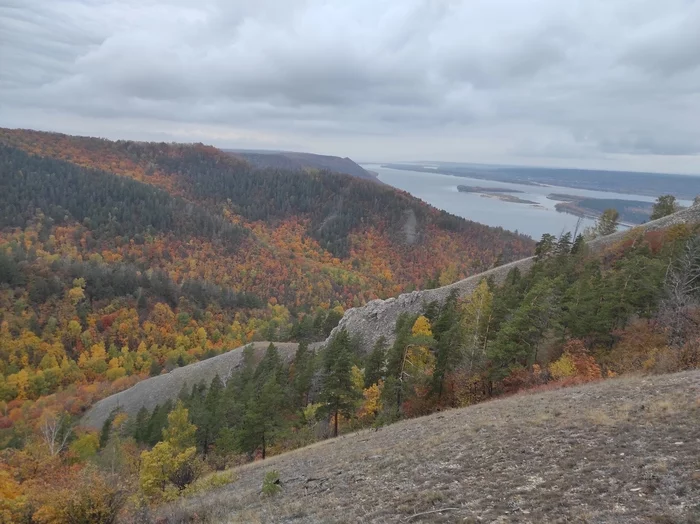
[4,219,700,522]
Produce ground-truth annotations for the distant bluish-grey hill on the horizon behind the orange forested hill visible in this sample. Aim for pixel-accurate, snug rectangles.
[225,149,378,182]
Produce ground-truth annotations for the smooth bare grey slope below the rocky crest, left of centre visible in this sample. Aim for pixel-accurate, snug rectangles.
[81,342,297,428]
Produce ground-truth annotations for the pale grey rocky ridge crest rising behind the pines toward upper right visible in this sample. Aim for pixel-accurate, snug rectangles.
[317,205,700,352]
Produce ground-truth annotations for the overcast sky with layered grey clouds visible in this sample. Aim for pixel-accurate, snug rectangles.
[0,0,700,174]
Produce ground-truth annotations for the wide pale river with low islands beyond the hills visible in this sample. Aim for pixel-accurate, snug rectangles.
[362,164,687,240]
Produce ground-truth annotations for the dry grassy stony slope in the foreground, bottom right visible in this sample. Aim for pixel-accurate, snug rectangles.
[153,372,700,523]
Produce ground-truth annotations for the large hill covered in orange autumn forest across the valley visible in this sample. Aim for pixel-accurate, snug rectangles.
[0,129,534,447]
